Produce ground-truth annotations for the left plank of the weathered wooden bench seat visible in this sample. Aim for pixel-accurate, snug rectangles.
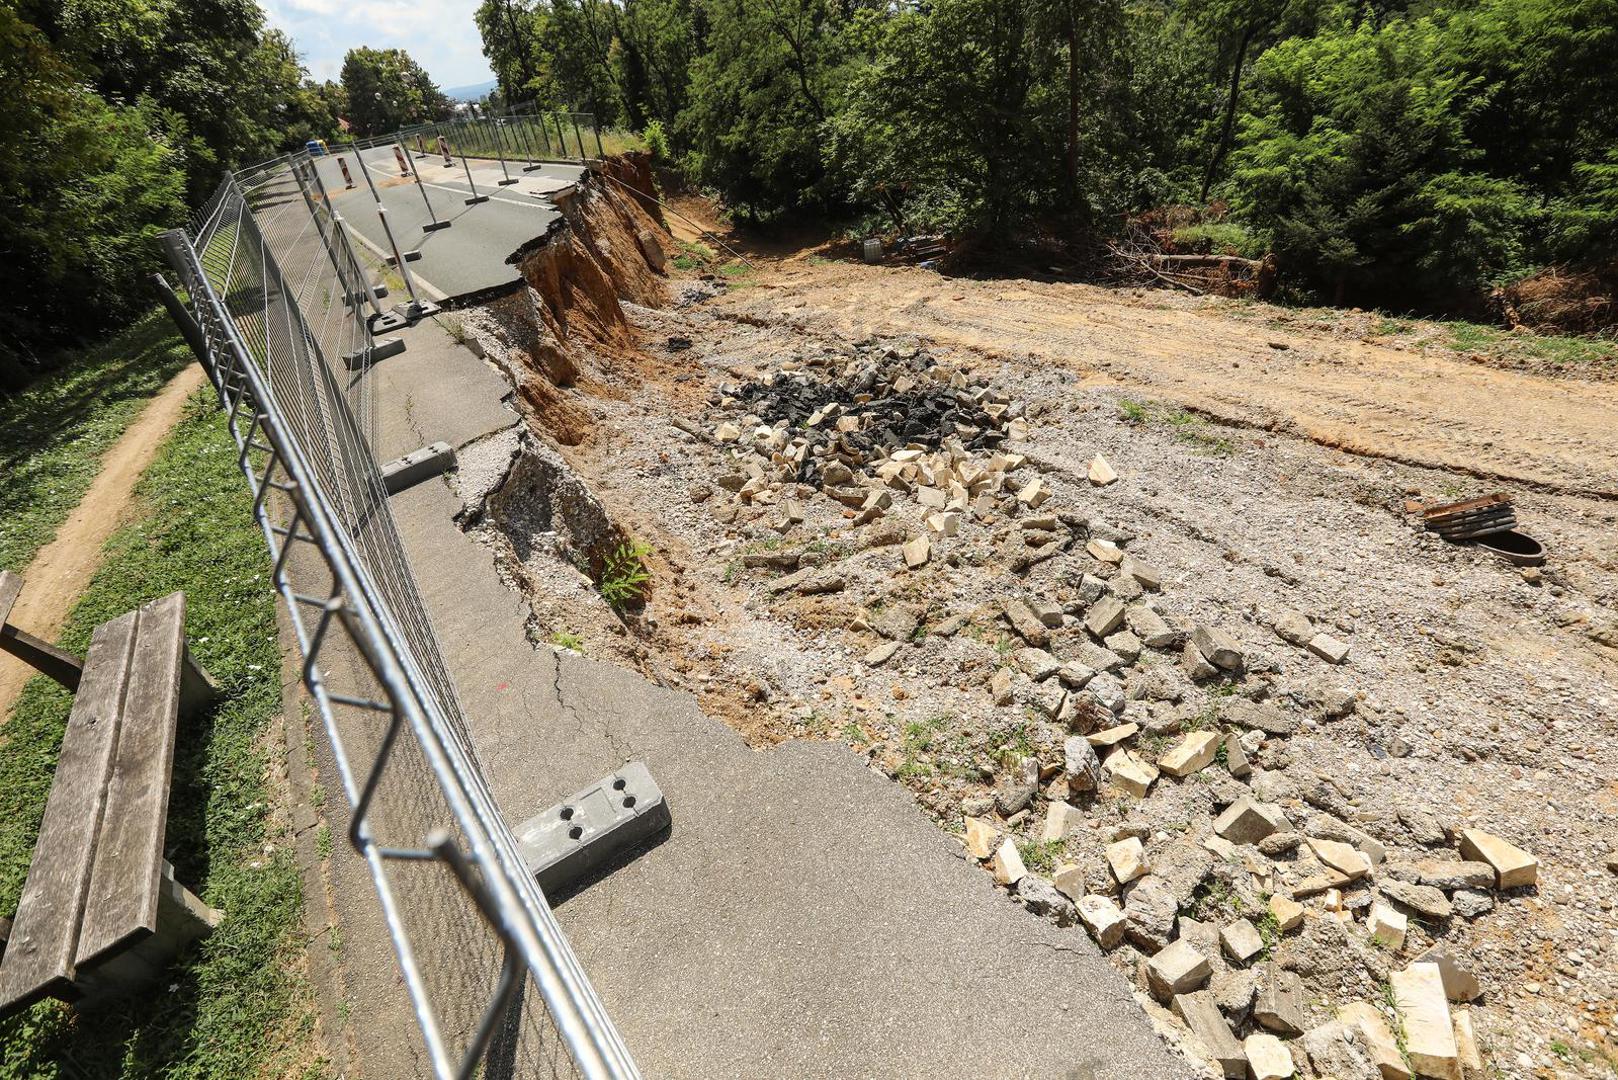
[0,612,138,1012]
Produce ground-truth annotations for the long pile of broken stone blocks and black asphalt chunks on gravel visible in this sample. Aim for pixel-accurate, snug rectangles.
[693,333,1537,1080]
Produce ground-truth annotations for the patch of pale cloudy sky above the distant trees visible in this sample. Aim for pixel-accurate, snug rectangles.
[262,0,493,89]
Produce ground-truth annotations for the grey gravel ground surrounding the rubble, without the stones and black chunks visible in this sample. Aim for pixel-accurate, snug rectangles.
[453,262,1618,1077]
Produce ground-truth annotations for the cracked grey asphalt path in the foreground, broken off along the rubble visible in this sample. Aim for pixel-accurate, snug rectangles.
[347,314,1192,1080]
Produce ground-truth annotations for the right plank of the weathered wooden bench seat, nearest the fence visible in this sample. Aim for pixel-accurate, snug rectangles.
[78,593,186,967]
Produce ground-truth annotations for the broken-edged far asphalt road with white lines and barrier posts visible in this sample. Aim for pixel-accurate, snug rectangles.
[305,146,584,300]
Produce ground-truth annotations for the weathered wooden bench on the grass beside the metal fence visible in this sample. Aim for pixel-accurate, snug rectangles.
[0,572,222,1015]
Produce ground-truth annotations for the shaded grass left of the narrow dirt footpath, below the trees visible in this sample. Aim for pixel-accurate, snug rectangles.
[0,311,193,570]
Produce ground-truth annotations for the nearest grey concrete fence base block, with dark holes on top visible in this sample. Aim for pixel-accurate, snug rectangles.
[515,761,671,899]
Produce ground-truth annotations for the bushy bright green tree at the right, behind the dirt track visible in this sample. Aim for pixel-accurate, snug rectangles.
[1231,19,1535,309]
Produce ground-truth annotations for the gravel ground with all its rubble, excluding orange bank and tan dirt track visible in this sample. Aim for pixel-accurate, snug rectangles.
[453,255,1618,1080]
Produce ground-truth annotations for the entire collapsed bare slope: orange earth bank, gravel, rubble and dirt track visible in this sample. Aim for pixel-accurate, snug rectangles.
[446,160,1618,1077]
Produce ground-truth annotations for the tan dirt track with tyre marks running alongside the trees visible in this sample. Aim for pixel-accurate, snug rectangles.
[725,259,1618,497]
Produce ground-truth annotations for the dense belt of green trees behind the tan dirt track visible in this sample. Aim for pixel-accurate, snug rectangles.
[477,0,1618,311]
